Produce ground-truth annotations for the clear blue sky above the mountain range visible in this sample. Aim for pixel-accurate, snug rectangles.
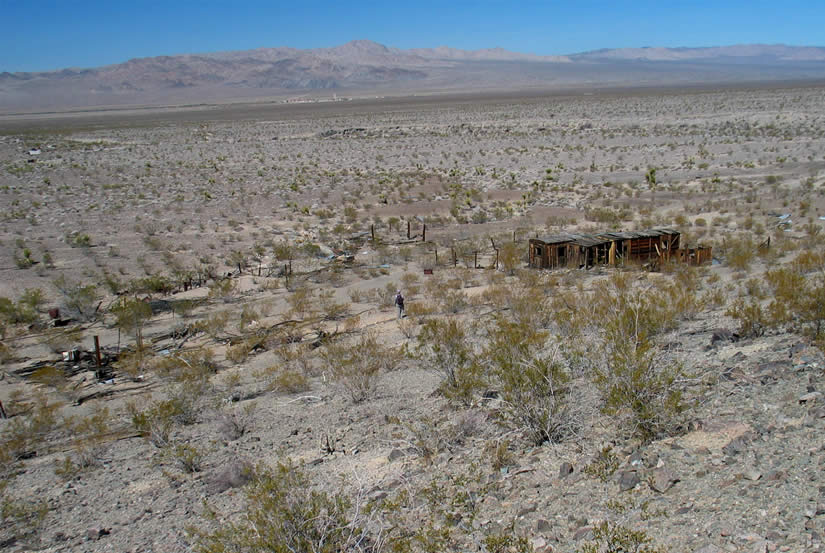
[0,0,825,72]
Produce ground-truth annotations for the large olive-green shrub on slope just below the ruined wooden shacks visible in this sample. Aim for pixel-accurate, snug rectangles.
[554,273,693,440]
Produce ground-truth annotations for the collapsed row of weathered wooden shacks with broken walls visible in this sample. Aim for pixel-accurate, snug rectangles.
[529,228,712,269]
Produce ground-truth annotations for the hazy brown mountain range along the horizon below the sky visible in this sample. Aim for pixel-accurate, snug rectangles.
[0,40,825,112]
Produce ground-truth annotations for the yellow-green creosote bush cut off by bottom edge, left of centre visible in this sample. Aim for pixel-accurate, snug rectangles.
[190,462,374,553]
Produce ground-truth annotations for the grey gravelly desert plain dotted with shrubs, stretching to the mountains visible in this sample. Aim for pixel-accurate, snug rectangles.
[0,82,825,553]
